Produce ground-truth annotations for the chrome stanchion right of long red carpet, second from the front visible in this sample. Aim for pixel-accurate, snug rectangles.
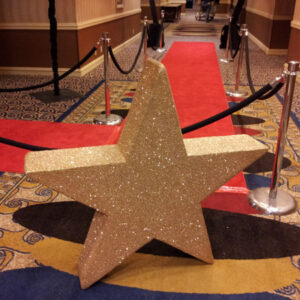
[226,24,248,98]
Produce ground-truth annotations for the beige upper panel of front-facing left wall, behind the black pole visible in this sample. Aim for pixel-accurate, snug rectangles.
[0,0,75,23]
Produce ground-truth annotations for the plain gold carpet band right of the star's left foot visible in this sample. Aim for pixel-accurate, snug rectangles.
[104,253,299,294]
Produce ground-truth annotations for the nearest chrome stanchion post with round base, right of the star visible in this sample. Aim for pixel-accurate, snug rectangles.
[249,61,299,215]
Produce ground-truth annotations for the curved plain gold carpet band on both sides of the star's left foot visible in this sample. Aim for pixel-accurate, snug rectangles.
[0,232,299,294]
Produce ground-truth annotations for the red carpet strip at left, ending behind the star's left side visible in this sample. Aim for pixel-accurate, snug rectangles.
[0,120,121,173]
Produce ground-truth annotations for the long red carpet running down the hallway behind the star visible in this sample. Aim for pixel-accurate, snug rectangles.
[162,42,247,192]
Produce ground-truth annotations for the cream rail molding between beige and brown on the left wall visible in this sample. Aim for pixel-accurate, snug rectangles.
[0,8,141,30]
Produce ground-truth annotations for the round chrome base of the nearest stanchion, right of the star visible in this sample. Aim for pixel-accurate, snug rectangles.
[248,187,297,216]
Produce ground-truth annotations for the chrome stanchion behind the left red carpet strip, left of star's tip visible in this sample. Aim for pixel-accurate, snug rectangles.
[94,32,122,125]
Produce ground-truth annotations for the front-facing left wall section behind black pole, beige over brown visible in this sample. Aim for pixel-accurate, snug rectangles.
[0,0,79,71]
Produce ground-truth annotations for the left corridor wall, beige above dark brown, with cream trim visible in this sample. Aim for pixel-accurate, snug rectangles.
[0,0,141,73]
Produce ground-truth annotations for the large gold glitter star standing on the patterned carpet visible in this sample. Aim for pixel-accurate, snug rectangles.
[25,60,266,288]
